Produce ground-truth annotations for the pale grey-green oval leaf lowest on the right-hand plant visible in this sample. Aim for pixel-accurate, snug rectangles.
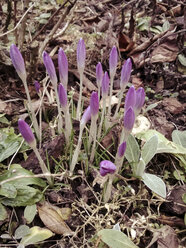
[142,173,166,198]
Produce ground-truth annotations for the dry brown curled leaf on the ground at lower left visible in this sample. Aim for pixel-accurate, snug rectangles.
[38,202,74,236]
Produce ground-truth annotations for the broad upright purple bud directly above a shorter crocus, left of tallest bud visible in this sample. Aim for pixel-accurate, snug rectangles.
[58,48,68,88]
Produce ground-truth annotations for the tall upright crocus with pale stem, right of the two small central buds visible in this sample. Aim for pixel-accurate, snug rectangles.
[108,46,118,116]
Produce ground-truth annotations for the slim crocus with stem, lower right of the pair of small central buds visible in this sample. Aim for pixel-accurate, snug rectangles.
[97,72,110,139]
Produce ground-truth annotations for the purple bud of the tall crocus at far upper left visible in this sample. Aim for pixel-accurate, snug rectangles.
[10,44,26,82]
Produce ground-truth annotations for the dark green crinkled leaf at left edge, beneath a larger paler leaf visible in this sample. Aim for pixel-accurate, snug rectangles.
[1,185,43,207]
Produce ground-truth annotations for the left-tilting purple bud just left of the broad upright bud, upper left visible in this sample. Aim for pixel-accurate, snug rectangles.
[43,51,57,87]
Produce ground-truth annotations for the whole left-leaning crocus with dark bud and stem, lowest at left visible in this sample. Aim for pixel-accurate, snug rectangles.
[18,119,53,186]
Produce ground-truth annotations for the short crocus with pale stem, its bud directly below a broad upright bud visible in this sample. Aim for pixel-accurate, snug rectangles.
[58,84,72,144]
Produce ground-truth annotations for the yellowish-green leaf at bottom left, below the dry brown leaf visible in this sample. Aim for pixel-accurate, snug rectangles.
[20,226,53,245]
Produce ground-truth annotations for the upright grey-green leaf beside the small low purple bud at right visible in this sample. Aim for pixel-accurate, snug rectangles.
[125,135,140,163]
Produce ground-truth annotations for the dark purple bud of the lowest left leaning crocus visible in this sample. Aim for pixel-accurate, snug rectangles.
[18,119,36,147]
